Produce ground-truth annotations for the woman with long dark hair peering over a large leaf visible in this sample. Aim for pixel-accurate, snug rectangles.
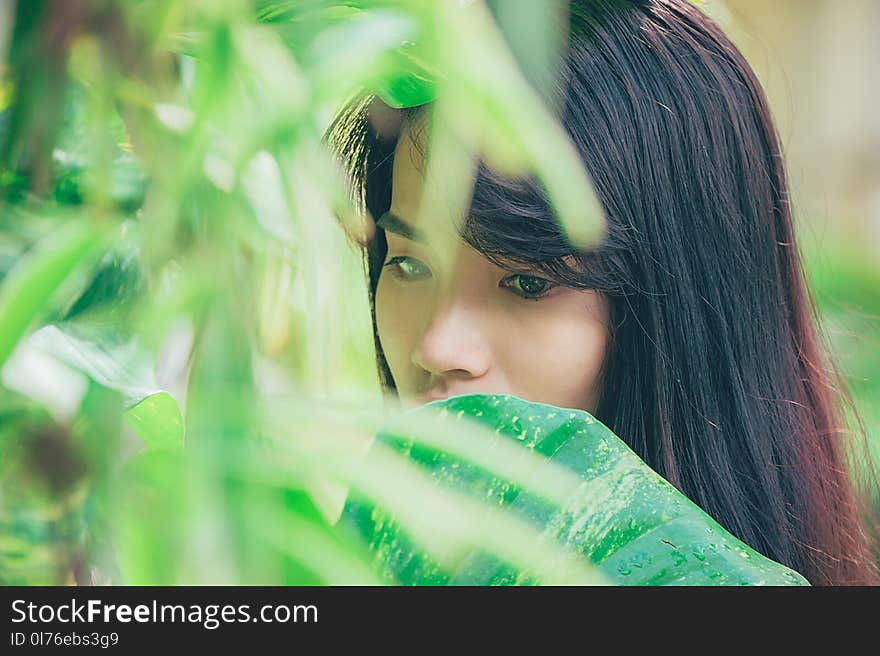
[328,0,876,584]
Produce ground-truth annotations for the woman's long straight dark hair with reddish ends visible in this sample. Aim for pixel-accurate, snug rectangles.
[327,0,876,584]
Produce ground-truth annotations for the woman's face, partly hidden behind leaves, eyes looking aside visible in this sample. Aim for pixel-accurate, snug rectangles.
[375,120,608,412]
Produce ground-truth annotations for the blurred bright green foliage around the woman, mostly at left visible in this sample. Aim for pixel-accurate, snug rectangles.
[0,0,880,584]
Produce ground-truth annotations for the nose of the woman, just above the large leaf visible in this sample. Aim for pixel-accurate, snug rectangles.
[412,303,491,379]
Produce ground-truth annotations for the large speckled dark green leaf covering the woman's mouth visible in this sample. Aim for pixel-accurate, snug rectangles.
[342,395,808,585]
